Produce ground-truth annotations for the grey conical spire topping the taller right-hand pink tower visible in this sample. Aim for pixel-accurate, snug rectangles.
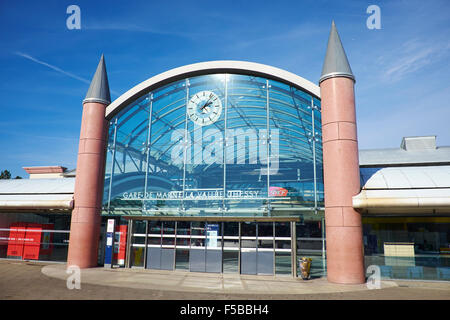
[319,21,355,83]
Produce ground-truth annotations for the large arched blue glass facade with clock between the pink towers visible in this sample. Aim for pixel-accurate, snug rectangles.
[103,74,323,218]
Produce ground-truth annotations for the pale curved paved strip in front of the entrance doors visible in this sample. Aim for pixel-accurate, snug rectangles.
[41,264,397,294]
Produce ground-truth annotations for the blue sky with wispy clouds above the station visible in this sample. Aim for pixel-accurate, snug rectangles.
[0,0,450,177]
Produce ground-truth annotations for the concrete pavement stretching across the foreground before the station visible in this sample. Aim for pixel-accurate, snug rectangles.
[0,260,450,300]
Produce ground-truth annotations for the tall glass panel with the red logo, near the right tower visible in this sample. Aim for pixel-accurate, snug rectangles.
[269,81,320,210]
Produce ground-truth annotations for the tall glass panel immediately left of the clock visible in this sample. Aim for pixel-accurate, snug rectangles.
[144,80,186,214]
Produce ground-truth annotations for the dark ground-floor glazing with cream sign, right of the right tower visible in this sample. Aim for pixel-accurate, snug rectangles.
[363,217,450,280]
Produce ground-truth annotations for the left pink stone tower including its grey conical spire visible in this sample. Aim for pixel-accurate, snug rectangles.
[67,55,111,268]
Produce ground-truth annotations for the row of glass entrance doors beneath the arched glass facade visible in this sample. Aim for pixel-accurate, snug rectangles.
[126,216,299,276]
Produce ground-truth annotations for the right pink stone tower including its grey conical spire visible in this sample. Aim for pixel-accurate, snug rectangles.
[319,21,365,284]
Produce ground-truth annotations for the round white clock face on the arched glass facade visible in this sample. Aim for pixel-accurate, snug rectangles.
[187,91,222,126]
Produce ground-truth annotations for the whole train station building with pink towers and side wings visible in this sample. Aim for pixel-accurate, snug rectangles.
[0,23,450,284]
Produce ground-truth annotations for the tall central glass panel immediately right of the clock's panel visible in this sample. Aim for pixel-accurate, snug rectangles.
[225,75,267,216]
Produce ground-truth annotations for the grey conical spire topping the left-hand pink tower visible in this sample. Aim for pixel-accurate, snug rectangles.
[83,54,111,105]
